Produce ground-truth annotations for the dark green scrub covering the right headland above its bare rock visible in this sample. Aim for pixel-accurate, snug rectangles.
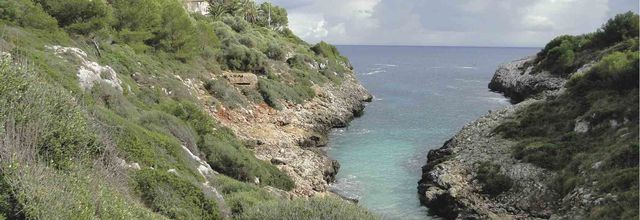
[496,13,639,219]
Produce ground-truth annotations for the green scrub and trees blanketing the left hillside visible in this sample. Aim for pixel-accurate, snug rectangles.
[0,0,370,219]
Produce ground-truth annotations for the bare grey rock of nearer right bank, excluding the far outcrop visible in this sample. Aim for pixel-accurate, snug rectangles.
[418,100,554,219]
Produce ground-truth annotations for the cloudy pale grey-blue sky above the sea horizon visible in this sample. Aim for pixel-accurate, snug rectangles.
[258,0,639,47]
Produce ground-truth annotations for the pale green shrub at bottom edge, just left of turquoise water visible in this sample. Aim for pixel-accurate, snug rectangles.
[240,198,380,220]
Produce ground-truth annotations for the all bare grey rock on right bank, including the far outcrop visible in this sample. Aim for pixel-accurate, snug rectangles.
[418,57,592,219]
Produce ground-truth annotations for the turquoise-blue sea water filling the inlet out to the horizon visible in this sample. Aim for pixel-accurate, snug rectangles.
[327,46,539,219]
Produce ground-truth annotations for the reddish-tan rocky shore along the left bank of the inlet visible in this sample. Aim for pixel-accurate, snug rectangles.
[199,74,372,197]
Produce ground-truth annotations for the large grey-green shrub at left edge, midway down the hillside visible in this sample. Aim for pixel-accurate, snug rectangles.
[0,61,100,168]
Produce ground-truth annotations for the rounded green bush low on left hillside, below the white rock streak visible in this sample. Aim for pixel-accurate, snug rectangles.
[134,169,220,219]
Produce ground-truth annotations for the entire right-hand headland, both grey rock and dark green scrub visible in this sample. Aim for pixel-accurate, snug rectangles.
[418,12,639,219]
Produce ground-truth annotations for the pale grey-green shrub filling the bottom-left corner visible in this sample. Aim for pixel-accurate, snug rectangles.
[1,163,164,219]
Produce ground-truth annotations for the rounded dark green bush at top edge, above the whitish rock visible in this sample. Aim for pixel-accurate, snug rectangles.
[36,0,113,35]
